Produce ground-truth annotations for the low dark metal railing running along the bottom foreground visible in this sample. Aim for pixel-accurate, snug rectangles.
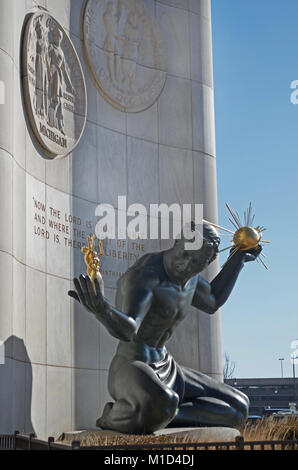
[0,431,298,451]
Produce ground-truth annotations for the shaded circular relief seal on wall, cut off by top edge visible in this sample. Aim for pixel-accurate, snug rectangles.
[83,0,167,112]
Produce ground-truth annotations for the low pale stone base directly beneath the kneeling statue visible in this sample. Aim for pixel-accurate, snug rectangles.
[58,427,240,443]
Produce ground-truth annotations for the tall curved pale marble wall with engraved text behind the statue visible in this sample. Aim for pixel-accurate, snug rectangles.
[0,0,222,437]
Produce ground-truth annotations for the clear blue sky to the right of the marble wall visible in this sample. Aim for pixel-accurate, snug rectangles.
[212,0,298,377]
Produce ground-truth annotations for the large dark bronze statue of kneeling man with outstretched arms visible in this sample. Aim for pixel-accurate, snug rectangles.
[69,224,262,434]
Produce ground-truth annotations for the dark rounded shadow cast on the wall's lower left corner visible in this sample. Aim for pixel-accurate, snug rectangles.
[0,336,35,434]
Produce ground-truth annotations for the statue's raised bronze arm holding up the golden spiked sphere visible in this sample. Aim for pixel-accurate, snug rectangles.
[192,246,262,314]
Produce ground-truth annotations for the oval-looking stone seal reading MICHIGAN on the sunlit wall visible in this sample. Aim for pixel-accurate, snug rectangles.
[22,13,87,158]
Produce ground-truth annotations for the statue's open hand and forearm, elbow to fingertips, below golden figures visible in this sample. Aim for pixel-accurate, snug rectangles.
[68,274,136,341]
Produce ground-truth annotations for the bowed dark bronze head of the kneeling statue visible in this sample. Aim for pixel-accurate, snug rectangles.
[171,223,220,278]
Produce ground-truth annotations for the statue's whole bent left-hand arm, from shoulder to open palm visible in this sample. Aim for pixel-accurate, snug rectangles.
[68,275,152,341]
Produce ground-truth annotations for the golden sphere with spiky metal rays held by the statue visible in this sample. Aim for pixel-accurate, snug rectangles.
[203,202,270,269]
